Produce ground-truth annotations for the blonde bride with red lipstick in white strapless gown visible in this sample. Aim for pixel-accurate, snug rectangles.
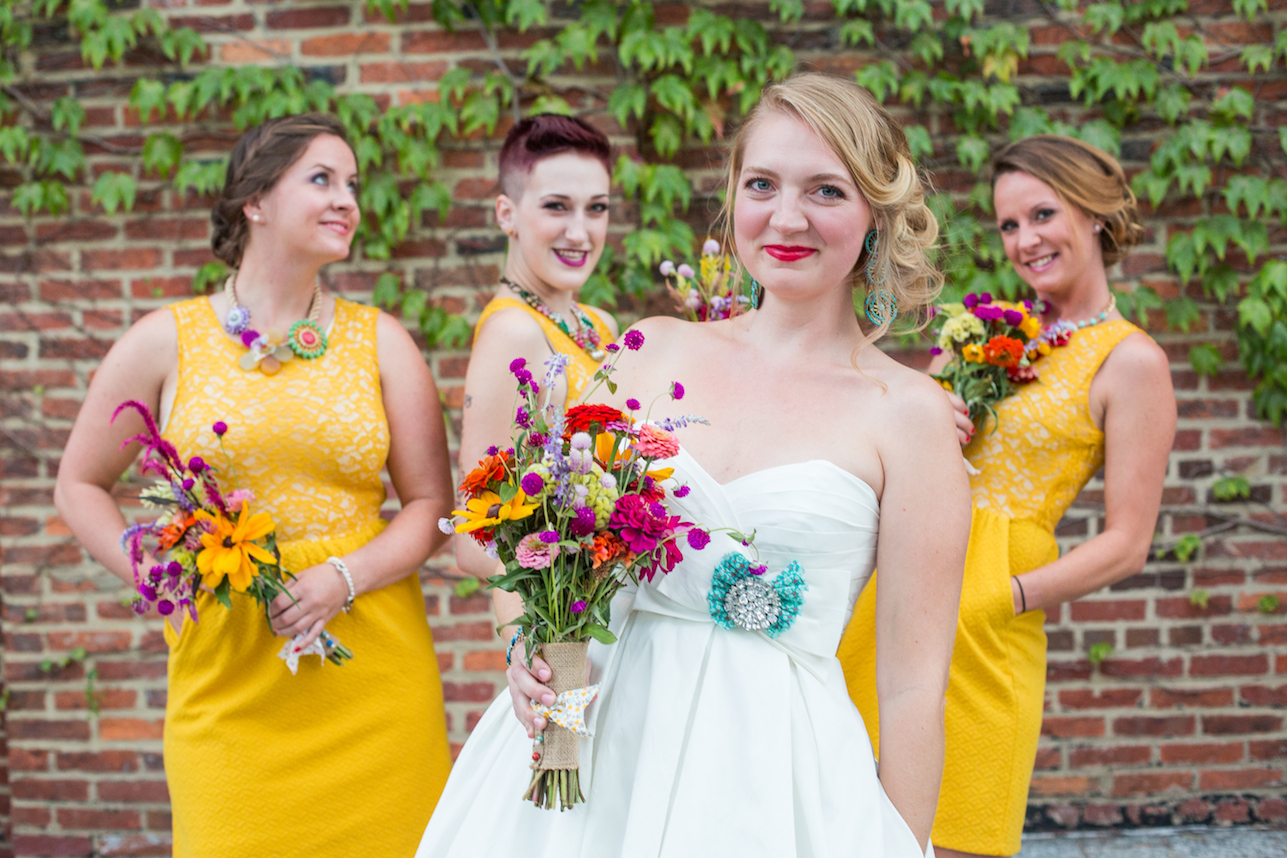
[417,75,969,858]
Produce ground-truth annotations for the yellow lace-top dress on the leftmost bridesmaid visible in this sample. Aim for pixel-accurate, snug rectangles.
[165,297,450,858]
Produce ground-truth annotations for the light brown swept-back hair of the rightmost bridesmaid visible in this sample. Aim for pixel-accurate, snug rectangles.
[992,134,1144,268]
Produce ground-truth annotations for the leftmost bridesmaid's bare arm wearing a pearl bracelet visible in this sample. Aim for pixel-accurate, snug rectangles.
[273,313,453,644]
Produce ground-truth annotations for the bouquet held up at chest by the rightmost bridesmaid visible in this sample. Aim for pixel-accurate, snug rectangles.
[931,292,1075,426]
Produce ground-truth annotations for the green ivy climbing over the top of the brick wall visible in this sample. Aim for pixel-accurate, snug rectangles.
[0,0,1287,424]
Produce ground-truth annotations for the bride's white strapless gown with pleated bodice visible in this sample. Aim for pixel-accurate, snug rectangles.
[416,450,933,858]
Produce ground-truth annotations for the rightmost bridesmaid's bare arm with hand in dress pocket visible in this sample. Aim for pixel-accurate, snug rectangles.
[1012,334,1175,612]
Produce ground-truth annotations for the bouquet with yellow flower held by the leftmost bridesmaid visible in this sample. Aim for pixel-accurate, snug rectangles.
[112,400,353,674]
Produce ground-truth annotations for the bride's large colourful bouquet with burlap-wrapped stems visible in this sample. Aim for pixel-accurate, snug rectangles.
[439,331,710,810]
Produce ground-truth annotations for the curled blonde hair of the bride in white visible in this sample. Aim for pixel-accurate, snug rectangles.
[721,72,943,345]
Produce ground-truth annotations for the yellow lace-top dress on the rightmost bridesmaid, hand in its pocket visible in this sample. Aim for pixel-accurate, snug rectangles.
[837,319,1139,855]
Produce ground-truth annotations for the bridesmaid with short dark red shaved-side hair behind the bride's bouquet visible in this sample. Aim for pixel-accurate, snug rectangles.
[456,113,616,702]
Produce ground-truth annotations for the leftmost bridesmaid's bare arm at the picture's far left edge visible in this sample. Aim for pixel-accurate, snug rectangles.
[54,310,179,585]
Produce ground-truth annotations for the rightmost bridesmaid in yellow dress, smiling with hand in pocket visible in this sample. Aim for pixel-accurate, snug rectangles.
[838,135,1175,858]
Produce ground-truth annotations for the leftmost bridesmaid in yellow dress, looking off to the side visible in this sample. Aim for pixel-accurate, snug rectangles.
[55,114,452,858]
